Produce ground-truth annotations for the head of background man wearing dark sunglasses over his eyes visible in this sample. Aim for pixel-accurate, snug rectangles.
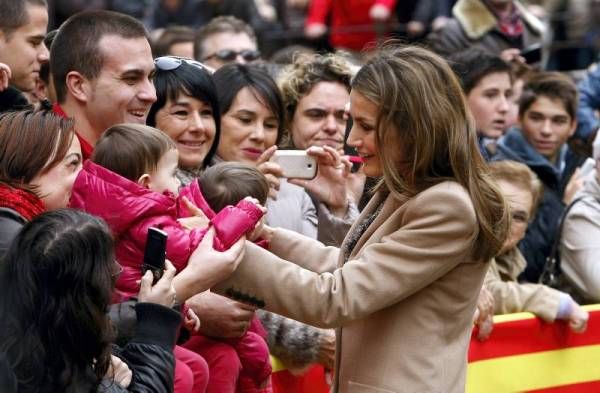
[194,16,260,69]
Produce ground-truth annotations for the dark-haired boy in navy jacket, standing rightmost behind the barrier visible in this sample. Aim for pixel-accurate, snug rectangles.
[494,72,585,282]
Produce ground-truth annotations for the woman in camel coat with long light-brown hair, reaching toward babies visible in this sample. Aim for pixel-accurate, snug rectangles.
[213,47,509,393]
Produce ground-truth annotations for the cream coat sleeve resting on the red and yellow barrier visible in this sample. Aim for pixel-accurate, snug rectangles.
[485,261,560,322]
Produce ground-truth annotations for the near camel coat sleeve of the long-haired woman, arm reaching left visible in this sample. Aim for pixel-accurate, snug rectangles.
[215,188,478,327]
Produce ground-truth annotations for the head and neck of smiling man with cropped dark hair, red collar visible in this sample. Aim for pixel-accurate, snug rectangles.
[50,11,156,158]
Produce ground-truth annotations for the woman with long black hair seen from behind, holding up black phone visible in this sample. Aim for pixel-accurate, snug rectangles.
[0,209,181,393]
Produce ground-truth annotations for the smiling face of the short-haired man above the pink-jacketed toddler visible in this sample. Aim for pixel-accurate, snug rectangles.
[84,35,156,136]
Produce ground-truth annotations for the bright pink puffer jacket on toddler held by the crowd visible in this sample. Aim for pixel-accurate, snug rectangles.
[70,160,263,301]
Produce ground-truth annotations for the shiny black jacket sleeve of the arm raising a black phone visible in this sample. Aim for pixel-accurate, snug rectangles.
[119,303,181,393]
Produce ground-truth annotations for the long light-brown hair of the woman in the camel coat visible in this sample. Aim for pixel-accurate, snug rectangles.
[352,46,509,260]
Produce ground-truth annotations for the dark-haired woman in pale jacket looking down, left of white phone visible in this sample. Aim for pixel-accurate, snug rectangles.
[214,64,349,238]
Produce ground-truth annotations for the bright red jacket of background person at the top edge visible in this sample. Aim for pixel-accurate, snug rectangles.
[306,0,396,51]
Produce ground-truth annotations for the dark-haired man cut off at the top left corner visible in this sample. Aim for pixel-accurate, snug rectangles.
[0,0,48,112]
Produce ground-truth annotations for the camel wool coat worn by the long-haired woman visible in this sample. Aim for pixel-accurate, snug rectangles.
[214,181,489,393]
